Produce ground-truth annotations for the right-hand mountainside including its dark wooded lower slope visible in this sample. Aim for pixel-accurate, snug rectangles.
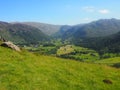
[51,19,120,54]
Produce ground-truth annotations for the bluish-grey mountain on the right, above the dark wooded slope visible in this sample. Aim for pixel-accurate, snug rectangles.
[62,19,120,40]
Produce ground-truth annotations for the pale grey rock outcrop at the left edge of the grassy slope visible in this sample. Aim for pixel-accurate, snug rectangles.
[1,41,21,52]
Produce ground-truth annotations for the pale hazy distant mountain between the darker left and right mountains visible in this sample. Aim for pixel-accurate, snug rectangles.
[22,22,62,36]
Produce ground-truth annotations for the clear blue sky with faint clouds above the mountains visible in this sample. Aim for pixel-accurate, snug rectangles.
[0,0,120,25]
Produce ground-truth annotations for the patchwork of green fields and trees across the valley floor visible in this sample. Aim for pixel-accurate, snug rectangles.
[25,45,100,62]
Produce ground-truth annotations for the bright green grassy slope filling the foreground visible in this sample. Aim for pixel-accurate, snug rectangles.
[0,47,120,90]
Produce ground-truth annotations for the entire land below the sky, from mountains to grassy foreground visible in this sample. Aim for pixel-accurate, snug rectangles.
[0,19,120,90]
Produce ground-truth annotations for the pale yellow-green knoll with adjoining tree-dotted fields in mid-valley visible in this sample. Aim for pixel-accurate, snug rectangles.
[57,45,99,62]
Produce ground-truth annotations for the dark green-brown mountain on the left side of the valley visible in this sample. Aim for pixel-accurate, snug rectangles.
[0,22,48,44]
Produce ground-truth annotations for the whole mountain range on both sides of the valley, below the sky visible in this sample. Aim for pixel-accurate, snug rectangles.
[0,19,120,50]
